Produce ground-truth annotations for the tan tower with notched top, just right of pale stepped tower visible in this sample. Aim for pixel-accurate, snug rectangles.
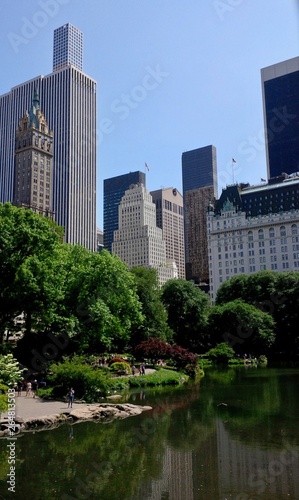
[151,188,185,278]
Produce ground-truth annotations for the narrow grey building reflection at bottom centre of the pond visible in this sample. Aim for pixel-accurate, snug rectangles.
[137,446,195,500]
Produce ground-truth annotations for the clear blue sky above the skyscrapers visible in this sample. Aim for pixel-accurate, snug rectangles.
[0,0,299,227]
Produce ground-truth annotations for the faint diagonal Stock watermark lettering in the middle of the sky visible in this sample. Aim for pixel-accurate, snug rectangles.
[95,64,169,144]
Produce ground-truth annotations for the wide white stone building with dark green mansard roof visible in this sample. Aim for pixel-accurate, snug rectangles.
[207,179,299,300]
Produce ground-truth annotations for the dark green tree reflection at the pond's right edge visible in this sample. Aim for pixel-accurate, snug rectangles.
[206,369,299,448]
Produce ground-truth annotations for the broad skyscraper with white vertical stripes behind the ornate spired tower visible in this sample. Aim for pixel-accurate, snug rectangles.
[0,25,96,250]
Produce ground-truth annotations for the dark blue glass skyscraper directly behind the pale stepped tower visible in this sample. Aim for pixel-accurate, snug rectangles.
[104,171,145,252]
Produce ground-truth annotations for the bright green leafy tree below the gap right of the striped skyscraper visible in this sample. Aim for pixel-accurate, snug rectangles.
[66,249,143,352]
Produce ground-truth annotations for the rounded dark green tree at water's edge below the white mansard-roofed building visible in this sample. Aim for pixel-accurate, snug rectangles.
[208,299,275,354]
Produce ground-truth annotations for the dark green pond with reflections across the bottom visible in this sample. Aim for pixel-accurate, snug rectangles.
[0,367,299,500]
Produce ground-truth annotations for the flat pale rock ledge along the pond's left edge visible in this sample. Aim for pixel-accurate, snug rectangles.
[0,403,152,437]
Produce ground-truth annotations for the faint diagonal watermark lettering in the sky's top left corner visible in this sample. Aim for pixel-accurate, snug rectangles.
[7,0,71,53]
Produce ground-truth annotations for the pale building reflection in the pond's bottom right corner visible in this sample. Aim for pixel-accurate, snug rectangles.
[216,420,299,500]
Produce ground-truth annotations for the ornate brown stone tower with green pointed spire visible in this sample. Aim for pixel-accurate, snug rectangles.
[14,92,53,217]
